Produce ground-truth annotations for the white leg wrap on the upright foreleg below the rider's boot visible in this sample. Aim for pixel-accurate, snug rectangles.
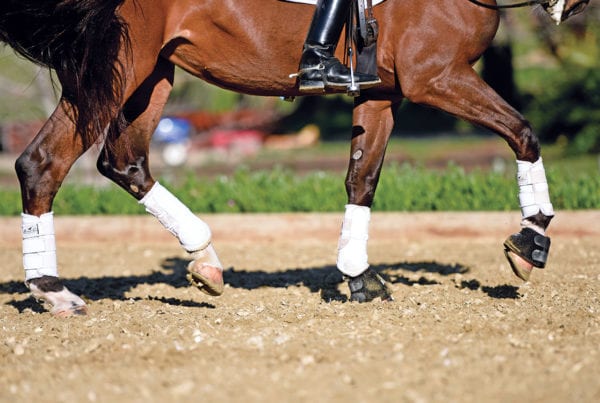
[337,204,371,277]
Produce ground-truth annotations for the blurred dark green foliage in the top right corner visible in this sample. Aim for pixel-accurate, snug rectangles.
[526,3,600,154]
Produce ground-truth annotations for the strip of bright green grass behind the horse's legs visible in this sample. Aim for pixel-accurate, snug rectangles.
[0,164,600,215]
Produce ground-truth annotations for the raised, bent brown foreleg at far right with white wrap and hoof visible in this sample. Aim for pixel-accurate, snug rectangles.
[401,63,554,281]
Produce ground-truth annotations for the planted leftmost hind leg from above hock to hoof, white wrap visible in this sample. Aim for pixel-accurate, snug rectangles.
[15,103,87,316]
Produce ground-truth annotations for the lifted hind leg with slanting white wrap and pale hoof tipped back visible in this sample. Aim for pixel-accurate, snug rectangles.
[97,59,224,295]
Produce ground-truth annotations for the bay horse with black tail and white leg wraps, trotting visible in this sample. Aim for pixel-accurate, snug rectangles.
[0,0,589,316]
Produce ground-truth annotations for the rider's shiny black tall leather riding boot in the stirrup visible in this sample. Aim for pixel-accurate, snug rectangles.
[298,0,381,91]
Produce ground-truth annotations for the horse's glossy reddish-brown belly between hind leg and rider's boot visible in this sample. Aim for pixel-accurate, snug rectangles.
[163,0,313,95]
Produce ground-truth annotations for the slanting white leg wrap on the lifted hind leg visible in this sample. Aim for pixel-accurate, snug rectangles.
[139,182,211,252]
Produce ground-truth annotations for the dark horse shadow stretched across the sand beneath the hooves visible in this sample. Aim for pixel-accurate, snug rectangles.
[0,257,521,312]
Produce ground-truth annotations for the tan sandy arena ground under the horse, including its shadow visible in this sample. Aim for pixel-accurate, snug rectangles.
[0,211,600,403]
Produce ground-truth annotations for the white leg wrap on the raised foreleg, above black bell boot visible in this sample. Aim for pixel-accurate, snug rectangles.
[517,157,554,218]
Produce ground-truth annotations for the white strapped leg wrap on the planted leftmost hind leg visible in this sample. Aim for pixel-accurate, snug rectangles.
[21,212,58,281]
